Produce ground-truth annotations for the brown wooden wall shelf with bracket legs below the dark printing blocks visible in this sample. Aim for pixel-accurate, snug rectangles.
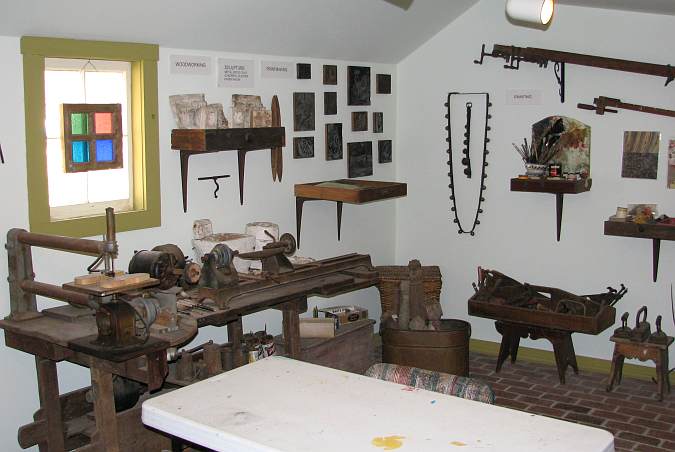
[295,179,408,248]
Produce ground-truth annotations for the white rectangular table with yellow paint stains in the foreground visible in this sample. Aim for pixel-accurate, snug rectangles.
[143,357,614,452]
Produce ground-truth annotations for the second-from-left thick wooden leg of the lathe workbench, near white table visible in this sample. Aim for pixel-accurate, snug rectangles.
[90,367,120,452]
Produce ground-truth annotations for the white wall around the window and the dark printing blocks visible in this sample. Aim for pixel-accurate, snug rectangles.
[0,37,398,451]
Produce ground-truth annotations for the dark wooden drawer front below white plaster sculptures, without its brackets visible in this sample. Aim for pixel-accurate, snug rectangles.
[171,127,286,152]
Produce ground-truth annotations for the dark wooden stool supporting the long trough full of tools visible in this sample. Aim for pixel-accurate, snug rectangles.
[495,321,579,384]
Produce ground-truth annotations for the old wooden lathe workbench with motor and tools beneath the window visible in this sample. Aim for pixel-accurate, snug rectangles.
[0,209,378,452]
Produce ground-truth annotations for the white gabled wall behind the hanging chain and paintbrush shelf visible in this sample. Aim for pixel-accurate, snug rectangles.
[396,0,675,359]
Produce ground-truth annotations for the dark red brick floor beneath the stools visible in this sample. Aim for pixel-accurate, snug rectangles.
[471,353,675,452]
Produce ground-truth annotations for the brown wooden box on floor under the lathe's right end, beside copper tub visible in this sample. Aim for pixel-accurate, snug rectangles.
[274,319,375,374]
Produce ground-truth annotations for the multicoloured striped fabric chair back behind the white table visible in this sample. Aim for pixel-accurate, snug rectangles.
[365,363,495,404]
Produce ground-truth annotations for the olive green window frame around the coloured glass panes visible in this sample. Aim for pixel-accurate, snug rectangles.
[21,36,161,237]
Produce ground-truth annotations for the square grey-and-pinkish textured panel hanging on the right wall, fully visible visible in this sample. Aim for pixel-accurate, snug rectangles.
[621,131,661,179]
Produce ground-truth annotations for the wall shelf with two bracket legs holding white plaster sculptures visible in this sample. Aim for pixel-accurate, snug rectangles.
[171,127,286,212]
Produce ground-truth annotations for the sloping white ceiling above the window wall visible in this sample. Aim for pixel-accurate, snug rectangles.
[0,0,476,63]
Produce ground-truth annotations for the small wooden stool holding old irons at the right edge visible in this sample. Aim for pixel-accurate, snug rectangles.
[607,336,674,401]
